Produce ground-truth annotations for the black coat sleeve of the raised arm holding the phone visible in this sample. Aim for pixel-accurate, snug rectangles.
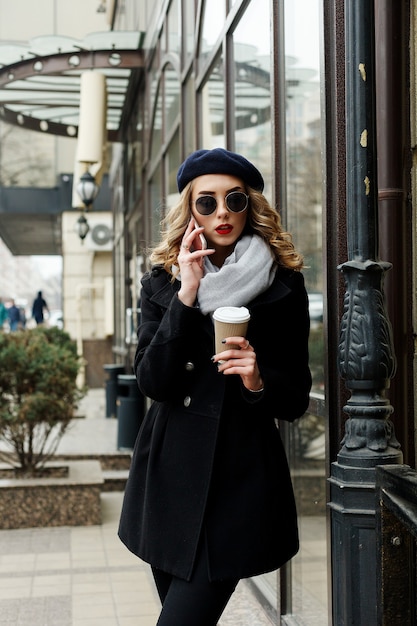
[134,273,202,402]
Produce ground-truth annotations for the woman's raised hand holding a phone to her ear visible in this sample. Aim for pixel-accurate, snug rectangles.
[178,217,214,306]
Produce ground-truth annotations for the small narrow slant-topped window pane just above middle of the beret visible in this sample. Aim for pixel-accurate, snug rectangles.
[200,58,226,149]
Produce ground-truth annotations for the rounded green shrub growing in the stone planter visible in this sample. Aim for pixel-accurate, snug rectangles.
[0,327,85,475]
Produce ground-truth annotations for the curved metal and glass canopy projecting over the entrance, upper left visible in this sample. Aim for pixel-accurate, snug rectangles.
[0,31,144,141]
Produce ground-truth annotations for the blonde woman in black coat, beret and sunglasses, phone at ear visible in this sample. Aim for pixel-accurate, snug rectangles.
[119,148,311,626]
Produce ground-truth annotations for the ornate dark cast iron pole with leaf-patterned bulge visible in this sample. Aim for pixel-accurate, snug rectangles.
[329,0,402,626]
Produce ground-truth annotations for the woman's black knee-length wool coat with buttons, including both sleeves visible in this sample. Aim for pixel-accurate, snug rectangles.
[119,267,311,580]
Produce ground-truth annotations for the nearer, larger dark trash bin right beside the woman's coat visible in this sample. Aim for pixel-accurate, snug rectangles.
[117,374,144,450]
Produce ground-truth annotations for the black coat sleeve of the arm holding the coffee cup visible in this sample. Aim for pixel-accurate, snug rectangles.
[249,272,311,421]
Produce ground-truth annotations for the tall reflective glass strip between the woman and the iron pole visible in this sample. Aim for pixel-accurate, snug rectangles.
[285,0,328,626]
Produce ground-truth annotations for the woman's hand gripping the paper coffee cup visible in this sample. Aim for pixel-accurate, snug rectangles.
[213,337,263,391]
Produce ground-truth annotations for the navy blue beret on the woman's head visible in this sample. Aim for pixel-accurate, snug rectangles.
[177,148,264,193]
